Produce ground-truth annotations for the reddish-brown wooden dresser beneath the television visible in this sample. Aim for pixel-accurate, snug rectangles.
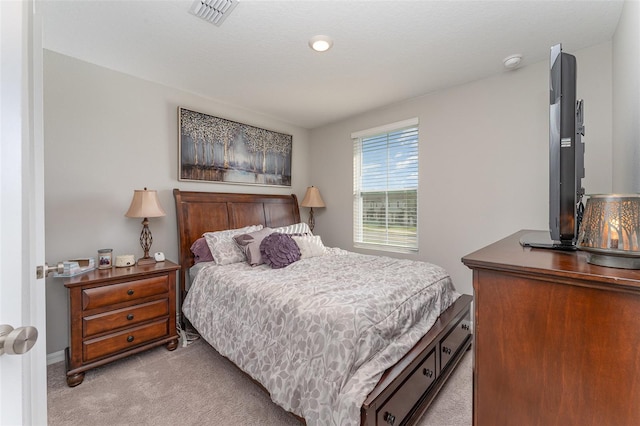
[462,231,640,426]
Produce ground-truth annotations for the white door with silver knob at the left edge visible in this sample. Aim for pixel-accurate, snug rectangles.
[0,0,47,425]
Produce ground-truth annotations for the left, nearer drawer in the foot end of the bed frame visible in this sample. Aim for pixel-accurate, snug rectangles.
[376,351,436,425]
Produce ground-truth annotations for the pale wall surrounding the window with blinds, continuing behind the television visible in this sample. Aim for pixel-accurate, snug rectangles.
[310,43,612,294]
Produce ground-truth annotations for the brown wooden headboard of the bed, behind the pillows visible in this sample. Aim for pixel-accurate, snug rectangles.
[173,188,300,303]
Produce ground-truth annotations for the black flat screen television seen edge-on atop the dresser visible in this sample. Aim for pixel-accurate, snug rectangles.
[521,44,584,250]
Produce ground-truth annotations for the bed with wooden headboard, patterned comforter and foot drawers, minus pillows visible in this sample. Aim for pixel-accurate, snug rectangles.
[173,189,471,426]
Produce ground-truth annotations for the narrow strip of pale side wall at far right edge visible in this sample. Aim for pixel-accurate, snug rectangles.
[613,0,640,193]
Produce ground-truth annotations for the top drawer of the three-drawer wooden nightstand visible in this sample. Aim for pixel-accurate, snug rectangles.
[82,275,169,310]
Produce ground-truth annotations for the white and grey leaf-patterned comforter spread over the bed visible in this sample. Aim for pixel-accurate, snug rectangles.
[182,248,459,426]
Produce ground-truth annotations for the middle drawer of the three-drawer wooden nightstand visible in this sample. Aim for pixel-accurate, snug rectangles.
[82,299,169,337]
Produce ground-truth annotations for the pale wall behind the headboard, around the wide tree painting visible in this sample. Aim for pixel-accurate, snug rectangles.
[44,51,310,354]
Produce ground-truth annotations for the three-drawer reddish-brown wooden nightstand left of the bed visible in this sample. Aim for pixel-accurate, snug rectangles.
[64,260,180,386]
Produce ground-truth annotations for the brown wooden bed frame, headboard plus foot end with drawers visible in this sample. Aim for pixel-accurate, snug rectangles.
[173,189,472,426]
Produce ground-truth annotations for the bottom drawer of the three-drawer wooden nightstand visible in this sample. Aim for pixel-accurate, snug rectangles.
[82,319,169,362]
